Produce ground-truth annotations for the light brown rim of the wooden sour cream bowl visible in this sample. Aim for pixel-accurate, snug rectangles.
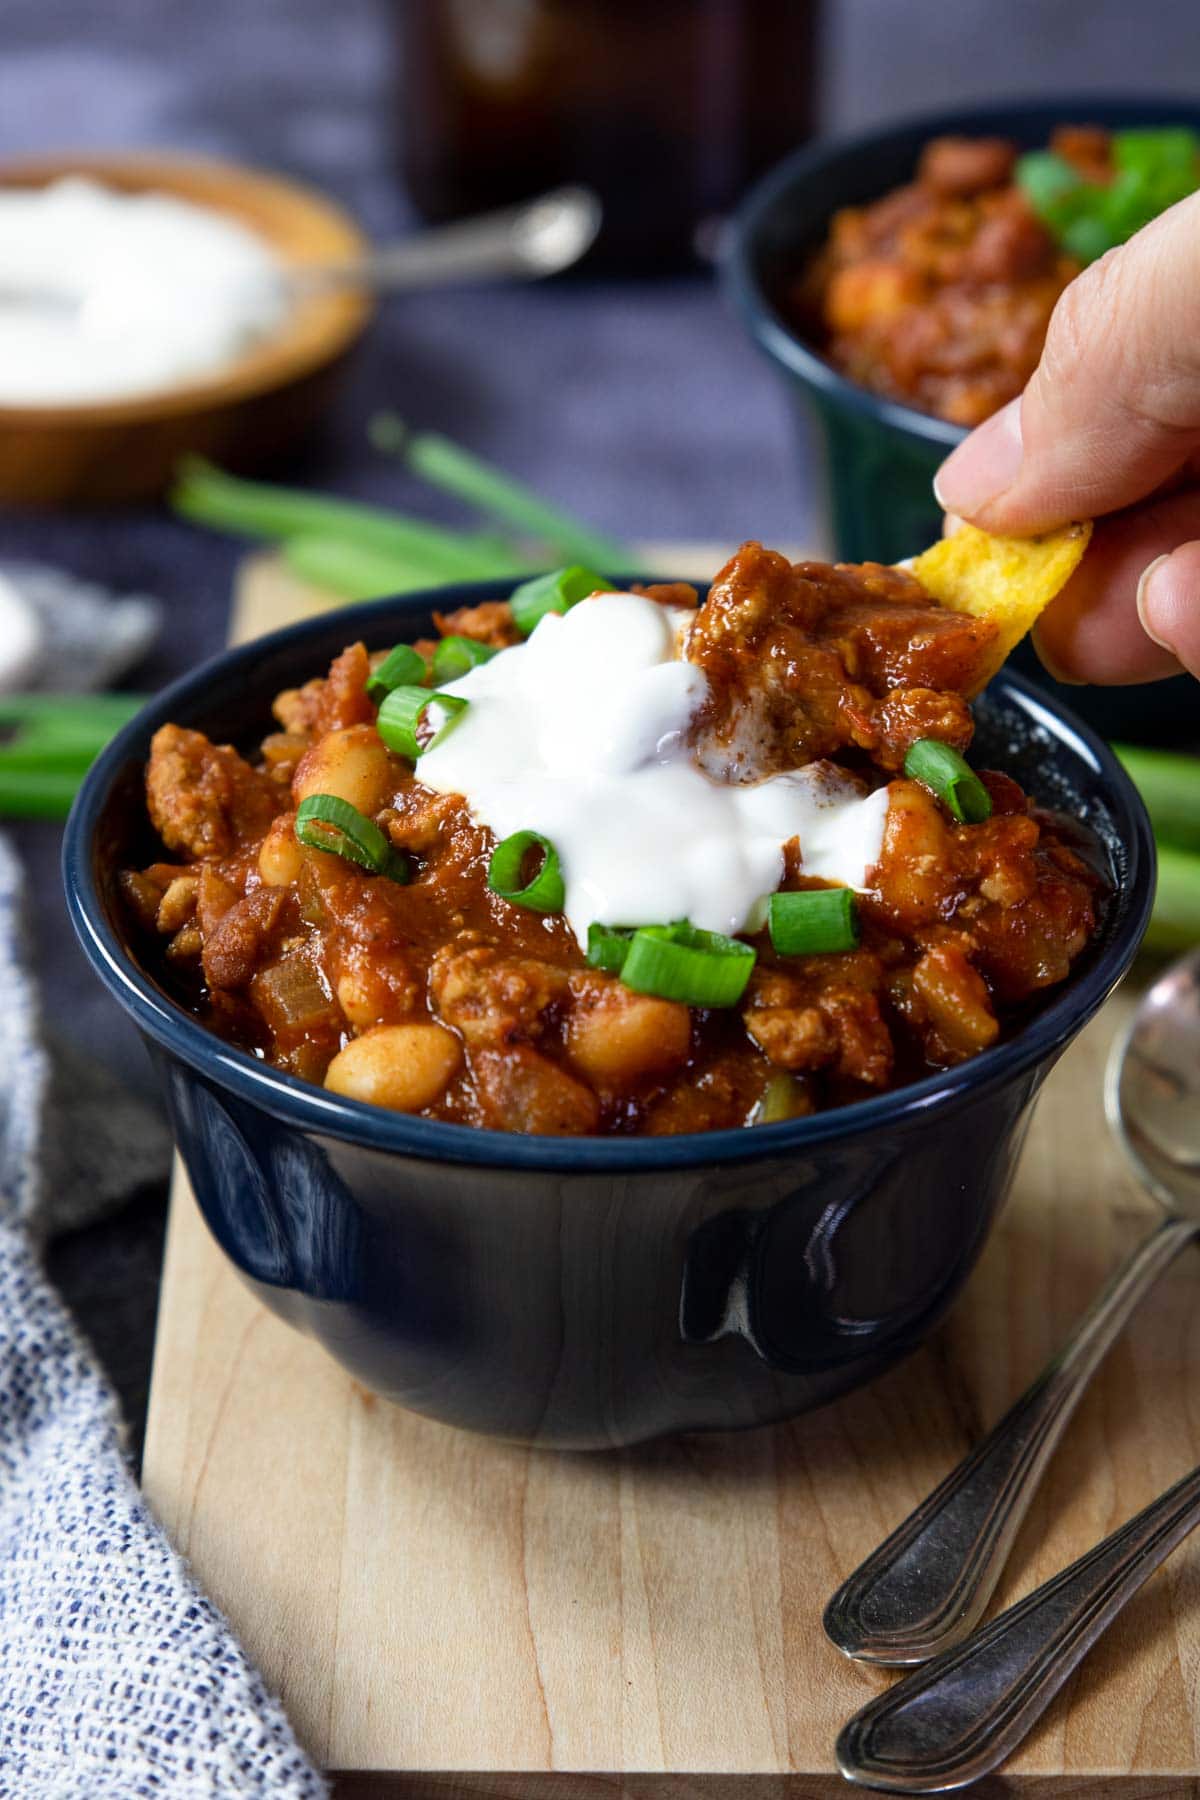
[0,144,374,434]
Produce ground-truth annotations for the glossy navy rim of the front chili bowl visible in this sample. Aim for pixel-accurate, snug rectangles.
[63,576,1155,1175]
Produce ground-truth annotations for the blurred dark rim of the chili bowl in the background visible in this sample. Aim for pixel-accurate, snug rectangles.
[721,94,1200,452]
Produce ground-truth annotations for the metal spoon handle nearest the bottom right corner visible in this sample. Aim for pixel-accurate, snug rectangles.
[837,1469,1200,1795]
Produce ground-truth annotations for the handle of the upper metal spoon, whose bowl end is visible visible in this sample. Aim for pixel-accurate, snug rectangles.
[824,1219,1200,1663]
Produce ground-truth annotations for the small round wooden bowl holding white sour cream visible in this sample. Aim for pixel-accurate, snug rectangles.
[0,153,372,506]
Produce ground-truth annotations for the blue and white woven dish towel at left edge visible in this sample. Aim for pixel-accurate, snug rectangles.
[0,568,326,1800]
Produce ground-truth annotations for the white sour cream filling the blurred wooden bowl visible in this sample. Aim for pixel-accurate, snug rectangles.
[0,176,290,407]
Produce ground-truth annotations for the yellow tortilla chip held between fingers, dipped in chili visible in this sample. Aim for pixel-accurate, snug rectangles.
[909,524,1092,698]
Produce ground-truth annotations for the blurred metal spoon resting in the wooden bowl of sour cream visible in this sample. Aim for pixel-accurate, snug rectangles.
[0,187,603,313]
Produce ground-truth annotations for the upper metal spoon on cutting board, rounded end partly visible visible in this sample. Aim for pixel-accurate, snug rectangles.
[824,952,1200,1665]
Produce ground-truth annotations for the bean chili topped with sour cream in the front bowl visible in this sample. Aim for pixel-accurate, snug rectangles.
[122,544,1097,1134]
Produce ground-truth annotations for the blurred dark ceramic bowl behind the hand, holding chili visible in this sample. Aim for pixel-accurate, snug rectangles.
[725,95,1200,743]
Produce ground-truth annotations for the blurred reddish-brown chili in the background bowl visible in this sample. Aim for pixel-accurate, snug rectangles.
[784,126,1112,425]
